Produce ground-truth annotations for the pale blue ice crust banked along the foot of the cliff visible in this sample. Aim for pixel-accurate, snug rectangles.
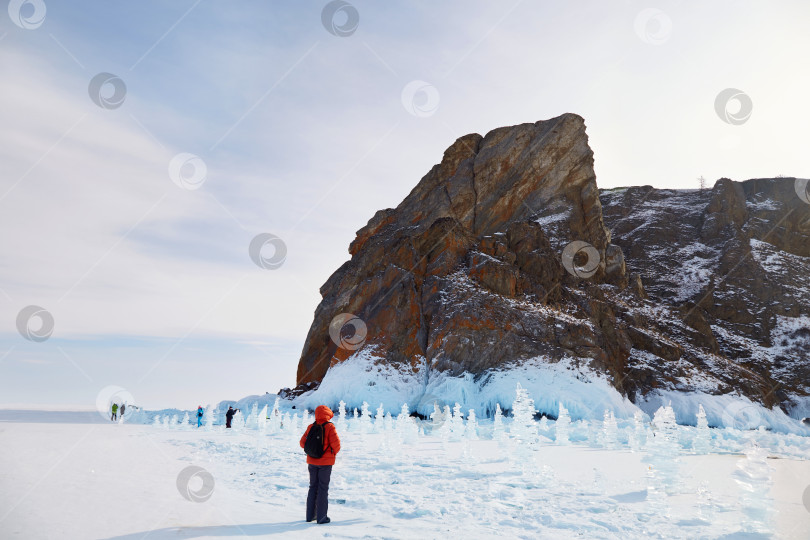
[292,350,810,435]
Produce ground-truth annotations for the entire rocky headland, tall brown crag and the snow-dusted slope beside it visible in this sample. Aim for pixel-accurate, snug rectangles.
[298,114,810,422]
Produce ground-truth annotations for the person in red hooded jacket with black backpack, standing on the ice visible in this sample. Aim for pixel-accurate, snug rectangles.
[301,405,340,524]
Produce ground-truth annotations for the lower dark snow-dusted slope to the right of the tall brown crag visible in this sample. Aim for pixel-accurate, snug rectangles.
[602,178,810,422]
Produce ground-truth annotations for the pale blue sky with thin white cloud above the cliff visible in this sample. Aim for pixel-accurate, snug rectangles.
[0,0,810,408]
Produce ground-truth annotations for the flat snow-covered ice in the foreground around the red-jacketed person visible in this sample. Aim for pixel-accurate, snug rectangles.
[0,400,810,539]
